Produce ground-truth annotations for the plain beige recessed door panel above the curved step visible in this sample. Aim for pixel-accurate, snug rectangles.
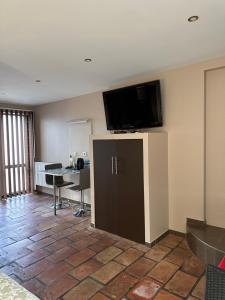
[206,67,225,228]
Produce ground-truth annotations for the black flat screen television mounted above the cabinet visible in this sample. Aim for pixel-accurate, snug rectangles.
[103,80,163,130]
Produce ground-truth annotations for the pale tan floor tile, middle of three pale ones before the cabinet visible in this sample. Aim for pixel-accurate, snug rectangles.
[91,261,125,284]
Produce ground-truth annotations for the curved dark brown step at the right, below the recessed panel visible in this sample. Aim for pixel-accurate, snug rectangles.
[187,219,225,265]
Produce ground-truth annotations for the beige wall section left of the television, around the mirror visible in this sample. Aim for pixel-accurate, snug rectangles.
[35,93,106,165]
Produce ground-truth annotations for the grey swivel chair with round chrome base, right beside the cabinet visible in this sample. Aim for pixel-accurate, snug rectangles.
[69,168,90,217]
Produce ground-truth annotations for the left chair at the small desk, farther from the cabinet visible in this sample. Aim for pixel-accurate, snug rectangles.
[45,163,74,209]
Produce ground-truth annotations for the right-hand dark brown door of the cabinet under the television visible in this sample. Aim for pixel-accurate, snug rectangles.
[116,139,145,243]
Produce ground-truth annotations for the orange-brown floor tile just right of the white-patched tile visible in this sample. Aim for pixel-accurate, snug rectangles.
[165,271,197,297]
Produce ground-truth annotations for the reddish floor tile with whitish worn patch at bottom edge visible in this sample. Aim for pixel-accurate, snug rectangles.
[128,278,160,300]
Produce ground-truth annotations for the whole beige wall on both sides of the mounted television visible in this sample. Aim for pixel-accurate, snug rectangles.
[35,57,225,232]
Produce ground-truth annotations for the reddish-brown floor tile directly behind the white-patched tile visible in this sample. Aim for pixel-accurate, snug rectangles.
[126,257,156,278]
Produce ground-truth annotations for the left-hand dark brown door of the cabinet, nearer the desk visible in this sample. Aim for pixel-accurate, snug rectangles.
[93,140,118,234]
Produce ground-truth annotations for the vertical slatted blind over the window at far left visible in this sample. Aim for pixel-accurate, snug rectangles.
[0,109,34,198]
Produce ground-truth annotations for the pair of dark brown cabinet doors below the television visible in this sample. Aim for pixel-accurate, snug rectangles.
[93,139,145,243]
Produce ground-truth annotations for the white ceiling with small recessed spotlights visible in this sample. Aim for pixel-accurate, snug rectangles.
[0,0,225,105]
